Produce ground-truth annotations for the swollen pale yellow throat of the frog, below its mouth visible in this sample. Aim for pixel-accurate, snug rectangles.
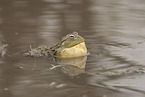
[57,42,87,58]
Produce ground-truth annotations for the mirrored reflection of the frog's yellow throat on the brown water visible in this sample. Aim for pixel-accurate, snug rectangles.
[56,56,87,76]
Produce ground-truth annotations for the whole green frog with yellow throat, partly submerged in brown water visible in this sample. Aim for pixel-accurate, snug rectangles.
[28,32,87,58]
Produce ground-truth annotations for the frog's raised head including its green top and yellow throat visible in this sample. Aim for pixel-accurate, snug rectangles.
[54,32,87,58]
